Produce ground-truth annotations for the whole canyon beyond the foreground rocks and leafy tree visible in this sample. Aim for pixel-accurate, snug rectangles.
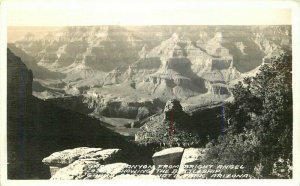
[7,26,291,179]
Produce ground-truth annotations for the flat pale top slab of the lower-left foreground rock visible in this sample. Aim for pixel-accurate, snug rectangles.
[42,147,121,177]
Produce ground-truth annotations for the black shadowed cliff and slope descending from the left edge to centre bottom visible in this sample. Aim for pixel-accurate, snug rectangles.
[7,50,155,179]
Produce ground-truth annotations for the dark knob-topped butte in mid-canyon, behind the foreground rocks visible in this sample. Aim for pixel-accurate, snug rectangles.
[135,99,221,147]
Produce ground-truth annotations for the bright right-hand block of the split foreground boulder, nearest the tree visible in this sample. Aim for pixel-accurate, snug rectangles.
[176,148,206,179]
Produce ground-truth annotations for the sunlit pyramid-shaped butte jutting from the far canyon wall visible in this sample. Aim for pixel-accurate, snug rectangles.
[136,33,206,99]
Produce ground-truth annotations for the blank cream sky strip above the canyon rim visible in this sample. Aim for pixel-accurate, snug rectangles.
[3,0,293,26]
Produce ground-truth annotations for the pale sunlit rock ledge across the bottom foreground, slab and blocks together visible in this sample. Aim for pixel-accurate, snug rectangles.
[43,147,207,180]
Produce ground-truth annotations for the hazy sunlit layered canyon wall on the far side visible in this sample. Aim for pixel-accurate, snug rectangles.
[11,26,291,119]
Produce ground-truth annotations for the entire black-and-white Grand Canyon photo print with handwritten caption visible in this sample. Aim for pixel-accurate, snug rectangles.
[1,1,299,185]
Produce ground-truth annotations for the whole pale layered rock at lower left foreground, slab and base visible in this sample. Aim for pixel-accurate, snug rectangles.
[42,147,123,180]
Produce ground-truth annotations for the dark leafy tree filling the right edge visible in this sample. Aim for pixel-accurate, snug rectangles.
[207,53,293,177]
